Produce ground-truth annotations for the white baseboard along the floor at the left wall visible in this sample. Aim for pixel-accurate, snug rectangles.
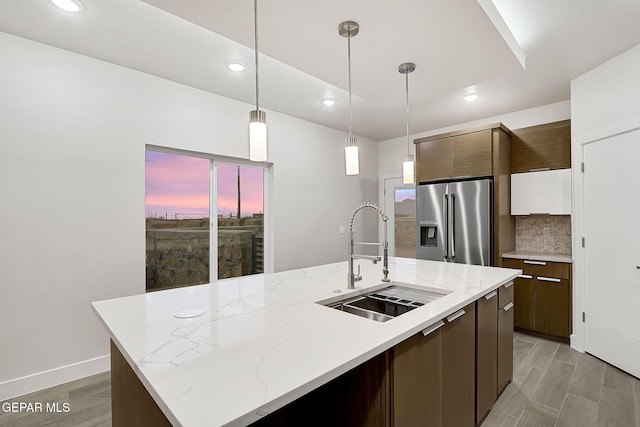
[0,355,110,402]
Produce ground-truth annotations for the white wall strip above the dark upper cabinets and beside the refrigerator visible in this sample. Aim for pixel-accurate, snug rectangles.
[378,101,571,177]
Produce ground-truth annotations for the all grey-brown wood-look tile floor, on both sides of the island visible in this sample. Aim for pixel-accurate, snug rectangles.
[0,333,640,427]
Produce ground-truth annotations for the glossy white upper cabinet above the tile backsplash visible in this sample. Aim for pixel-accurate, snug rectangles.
[511,169,571,215]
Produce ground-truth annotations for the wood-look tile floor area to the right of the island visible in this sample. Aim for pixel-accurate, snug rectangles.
[482,333,640,427]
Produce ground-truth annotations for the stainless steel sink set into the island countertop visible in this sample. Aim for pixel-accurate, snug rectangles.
[320,282,450,322]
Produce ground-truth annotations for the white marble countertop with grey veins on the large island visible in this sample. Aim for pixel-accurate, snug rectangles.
[93,258,521,427]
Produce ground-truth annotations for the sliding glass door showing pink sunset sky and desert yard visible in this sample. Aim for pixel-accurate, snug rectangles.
[145,150,265,291]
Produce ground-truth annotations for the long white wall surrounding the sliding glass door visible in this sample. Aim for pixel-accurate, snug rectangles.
[0,33,378,400]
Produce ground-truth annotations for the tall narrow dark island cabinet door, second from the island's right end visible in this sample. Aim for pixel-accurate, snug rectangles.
[476,291,498,424]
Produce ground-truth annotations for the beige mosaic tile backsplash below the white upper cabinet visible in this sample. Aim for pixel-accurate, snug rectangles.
[516,215,571,254]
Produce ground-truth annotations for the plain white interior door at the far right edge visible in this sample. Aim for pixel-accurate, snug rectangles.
[584,130,640,377]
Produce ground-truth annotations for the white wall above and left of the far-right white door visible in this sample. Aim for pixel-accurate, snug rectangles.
[571,41,640,351]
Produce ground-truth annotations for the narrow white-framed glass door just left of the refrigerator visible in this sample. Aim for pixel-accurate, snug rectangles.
[382,177,416,258]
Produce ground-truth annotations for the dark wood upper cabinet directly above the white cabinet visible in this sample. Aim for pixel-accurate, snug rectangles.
[511,120,571,173]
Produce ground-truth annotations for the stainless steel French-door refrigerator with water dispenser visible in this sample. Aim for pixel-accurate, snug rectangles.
[416,179,493,265]
